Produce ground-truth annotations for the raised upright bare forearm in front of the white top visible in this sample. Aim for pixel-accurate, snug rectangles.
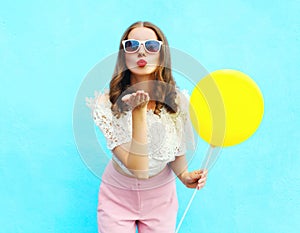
[126,108,149,179]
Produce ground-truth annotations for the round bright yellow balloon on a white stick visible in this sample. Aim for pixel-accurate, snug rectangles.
[190,70,264,146]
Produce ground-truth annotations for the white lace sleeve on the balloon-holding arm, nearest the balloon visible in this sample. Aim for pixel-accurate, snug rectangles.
[177,90,195,156]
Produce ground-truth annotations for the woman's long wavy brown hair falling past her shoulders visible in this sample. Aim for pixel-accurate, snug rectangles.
[109,21,177,117]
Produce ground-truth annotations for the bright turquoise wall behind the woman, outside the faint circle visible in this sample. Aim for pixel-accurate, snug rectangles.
[0,0,300,233]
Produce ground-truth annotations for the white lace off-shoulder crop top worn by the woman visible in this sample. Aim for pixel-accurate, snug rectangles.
[87,91,194,176]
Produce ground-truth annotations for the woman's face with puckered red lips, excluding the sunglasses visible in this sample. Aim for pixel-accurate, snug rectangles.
[125,27,159,75]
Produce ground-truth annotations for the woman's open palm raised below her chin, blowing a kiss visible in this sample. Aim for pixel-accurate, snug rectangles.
[122,90,150,109]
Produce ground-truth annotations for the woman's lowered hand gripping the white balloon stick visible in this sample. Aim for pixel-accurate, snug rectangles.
[181,170,207,190]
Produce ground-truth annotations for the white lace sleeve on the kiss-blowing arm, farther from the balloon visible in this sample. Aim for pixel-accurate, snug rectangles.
[86,92,131,150]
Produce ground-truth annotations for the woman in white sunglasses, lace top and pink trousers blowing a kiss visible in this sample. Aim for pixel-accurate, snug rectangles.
[88,22,207,233]
